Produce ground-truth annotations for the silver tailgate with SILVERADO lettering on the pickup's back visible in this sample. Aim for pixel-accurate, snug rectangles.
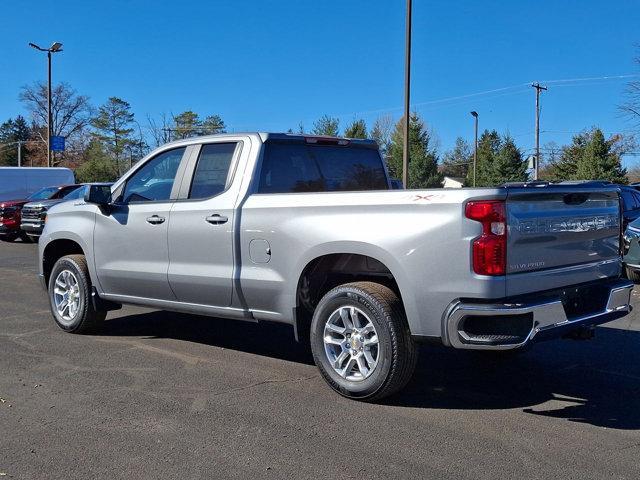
[507,185,621,278]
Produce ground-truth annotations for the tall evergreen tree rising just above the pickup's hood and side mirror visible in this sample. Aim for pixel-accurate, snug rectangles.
[91,97,136,176]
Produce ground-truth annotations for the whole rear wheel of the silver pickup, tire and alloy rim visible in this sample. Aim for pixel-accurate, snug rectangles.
[311,282,418,401]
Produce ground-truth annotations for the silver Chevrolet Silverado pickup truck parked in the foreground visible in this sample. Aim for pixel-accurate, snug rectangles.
[39,133,632,400]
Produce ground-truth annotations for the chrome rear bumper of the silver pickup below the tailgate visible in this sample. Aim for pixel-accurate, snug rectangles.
[443,279,633,350]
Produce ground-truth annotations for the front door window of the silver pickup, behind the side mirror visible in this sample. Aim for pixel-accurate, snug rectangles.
[122,147,186,203]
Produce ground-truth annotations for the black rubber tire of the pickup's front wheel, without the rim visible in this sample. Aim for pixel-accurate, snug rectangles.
[48,255,107,333]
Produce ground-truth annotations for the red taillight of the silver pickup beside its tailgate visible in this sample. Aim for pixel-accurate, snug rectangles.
[465,200,507,275]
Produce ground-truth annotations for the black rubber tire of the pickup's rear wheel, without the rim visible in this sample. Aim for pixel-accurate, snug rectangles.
[311,282,418,402]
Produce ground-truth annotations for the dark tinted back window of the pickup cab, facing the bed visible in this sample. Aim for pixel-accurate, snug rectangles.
[258,142,389,193]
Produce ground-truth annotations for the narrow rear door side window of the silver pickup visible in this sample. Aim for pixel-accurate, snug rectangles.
[189,142,238,199]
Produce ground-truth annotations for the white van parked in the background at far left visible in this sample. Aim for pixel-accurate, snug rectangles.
[0,167,76,201]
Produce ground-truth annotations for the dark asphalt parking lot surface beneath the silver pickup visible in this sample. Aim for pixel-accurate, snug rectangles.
[0,242,640,480]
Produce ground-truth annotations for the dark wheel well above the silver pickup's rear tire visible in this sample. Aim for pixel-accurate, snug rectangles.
[296,253,402,339]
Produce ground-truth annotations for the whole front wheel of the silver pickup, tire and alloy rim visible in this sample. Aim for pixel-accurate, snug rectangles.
[49,255,107,333]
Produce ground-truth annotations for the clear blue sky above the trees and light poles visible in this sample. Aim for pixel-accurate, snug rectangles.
[0,0,640,162]
